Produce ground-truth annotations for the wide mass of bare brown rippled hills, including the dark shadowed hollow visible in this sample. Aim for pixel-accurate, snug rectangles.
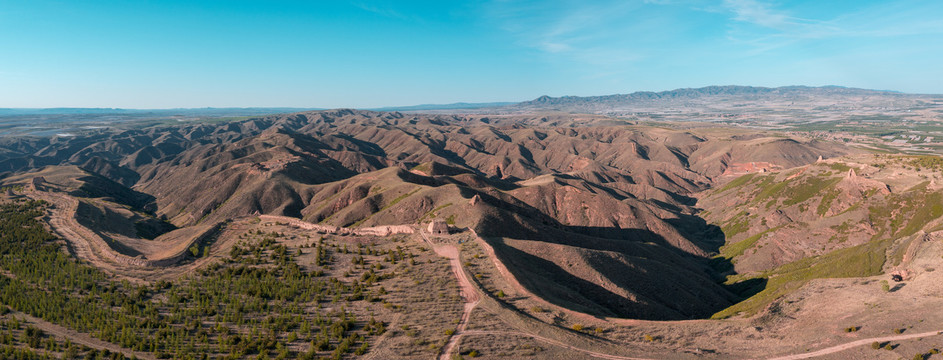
[0,110,853,319]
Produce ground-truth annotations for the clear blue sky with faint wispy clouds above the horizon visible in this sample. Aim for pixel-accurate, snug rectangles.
[0,0,943,108]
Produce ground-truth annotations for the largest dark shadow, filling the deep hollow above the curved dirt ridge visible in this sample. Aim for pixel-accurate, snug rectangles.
[460,179,767,320]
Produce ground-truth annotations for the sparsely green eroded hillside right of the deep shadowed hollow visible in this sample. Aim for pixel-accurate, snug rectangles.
[698,155,943,317]
